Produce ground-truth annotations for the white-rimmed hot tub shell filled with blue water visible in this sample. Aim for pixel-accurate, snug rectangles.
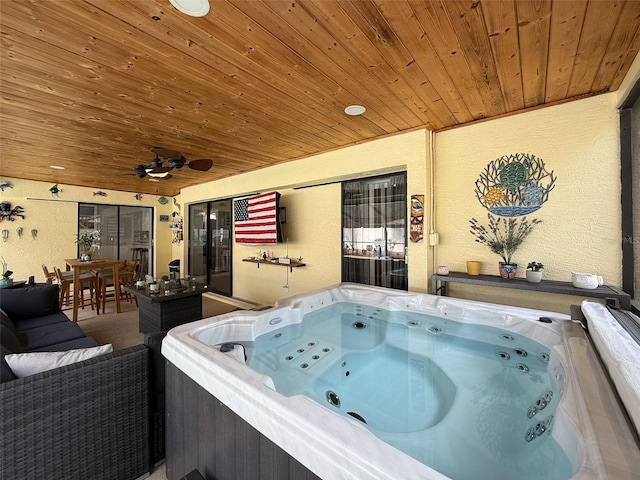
[162,284,640,480]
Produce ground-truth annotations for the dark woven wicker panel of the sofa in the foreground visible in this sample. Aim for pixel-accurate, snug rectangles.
[0,345,150,480]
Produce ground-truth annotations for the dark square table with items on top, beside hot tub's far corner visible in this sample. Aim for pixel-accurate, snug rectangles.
[123,283,209,333]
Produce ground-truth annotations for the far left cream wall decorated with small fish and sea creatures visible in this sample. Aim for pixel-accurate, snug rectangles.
[0,177,172,282]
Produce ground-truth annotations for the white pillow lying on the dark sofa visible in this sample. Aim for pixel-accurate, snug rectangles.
[4,343,113,378]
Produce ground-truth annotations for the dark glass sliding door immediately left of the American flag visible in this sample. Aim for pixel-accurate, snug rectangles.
[189,200,232,297]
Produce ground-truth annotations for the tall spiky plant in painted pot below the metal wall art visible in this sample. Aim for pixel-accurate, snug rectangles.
[469,213,542,279]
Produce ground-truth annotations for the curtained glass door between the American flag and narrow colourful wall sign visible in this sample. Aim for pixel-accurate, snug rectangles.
[342,173,408,290]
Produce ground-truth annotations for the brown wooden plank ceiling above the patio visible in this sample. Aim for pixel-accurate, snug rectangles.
[0,0,640,195]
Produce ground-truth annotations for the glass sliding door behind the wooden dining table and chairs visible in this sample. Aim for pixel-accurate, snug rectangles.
[78,203,153,278]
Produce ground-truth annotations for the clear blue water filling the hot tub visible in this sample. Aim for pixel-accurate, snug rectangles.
[244,303,574,480]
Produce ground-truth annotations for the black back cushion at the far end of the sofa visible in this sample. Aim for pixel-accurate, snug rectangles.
[0,284,60,322]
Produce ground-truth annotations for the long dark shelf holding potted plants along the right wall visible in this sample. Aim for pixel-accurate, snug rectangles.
[431,272,631,310]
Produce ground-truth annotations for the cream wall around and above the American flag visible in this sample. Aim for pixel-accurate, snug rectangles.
[181,130,429,304]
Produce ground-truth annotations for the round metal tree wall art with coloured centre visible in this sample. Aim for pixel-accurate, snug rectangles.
[475,153,556,217]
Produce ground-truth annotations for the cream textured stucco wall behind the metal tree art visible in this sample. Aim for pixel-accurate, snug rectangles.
[435,94,622,311]
